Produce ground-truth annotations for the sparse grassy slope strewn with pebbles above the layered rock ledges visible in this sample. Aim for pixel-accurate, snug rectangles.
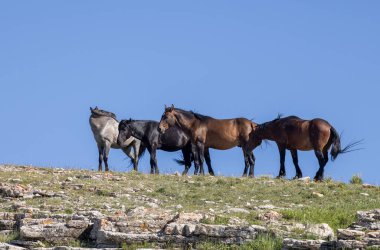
[0,166,380,249]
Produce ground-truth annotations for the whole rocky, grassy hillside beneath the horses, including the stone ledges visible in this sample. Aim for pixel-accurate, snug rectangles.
[0,165,380,249]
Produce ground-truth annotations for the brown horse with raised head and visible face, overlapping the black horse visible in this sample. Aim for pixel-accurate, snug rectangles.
[159,105,261,177]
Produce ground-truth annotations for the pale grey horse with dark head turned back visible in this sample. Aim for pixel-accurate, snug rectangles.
[89,107,145,171]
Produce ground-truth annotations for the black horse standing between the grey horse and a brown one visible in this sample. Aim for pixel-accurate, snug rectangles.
[117,119,214,175]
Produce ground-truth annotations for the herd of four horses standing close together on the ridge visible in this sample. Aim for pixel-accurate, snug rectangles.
[90,105,360,181]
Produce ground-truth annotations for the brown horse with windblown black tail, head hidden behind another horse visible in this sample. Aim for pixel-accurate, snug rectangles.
[253,115,361,181]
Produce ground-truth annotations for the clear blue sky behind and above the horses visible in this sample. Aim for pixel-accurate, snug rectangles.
[0,0,380,184]
